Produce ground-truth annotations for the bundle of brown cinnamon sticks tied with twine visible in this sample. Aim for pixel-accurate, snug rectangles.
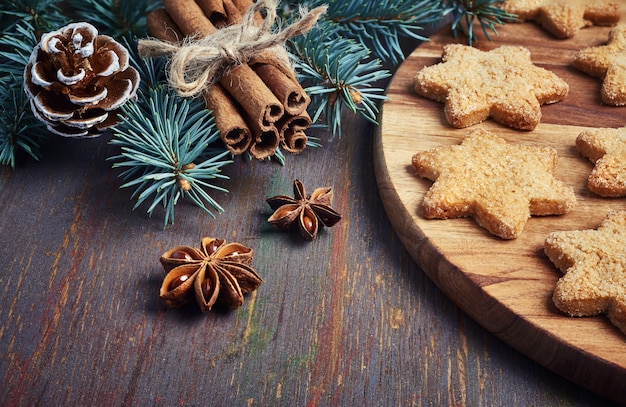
[147,0,311,159]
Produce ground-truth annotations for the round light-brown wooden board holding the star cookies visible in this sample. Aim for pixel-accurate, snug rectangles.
[374,11,626,403]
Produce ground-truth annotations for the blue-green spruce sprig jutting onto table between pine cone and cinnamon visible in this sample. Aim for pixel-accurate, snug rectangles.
[110,86,232,226]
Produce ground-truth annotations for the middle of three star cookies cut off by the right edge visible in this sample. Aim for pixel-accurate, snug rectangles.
[576,127,626,197]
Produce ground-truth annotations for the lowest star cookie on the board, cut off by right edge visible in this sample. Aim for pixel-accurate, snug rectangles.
[544,211,626,334]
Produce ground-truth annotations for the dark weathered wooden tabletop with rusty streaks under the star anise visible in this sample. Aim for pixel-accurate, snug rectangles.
[0,26,611,406]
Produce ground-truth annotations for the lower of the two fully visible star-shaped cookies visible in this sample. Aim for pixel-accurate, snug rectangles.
[412,129,576,239]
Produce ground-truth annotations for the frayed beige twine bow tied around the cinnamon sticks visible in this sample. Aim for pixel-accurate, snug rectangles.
[138,0,327,97]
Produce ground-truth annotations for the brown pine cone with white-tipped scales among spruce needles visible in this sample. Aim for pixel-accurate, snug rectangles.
[24,23,139,137]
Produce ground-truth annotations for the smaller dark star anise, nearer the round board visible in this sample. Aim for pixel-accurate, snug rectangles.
[267,180,341,240]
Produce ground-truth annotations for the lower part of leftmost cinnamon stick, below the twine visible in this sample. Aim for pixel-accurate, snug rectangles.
[204,83,252,155]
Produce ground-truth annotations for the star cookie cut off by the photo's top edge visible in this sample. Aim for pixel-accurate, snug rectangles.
[501,0,619,38]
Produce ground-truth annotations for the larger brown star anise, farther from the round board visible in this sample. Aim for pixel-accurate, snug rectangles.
[159,237,263,312]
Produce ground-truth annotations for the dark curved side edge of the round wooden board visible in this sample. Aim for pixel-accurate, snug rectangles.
[373,100,626,404]
